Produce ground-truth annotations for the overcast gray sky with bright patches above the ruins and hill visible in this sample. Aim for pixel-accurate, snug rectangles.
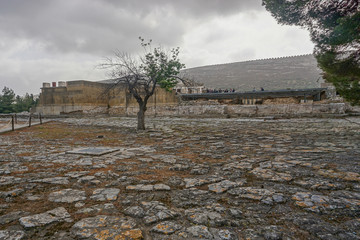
[0,0,314,95]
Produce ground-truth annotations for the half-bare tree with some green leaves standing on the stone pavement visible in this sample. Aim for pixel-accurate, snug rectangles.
[100,37,185,130]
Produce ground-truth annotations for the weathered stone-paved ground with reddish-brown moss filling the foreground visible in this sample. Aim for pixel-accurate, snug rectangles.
[0,118,360,240]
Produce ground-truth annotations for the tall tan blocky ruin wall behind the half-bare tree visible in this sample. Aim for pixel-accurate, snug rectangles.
[36,80,178,115]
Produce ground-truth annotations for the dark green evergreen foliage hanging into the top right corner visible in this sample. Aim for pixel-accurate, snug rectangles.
[263,0,360,105]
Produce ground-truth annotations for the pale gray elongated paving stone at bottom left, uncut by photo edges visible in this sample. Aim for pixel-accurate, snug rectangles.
[19,207,72,228]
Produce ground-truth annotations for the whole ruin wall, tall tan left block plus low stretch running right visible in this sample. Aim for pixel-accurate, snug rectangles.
[36,81,358,117]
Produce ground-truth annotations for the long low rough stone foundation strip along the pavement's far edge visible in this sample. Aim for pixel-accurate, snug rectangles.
[38,102,360,117]
